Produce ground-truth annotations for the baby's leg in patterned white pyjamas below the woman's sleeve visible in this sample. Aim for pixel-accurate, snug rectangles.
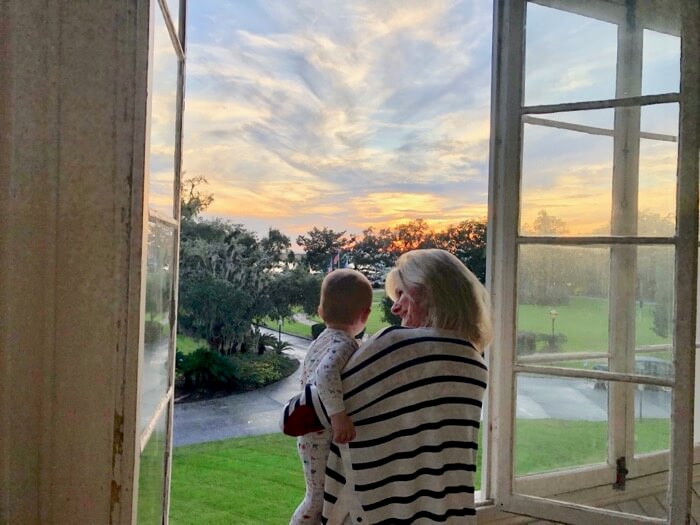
[289,430,331,525]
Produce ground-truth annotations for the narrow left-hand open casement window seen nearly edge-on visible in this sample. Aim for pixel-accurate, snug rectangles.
[134,0,186,524]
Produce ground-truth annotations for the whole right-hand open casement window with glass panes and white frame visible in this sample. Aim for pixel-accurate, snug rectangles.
[485,0,700,524]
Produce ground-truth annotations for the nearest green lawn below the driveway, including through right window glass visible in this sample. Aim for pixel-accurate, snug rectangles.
[170,419,669,525]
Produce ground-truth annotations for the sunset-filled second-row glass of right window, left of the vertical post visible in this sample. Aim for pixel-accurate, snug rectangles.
[520,115,614,236]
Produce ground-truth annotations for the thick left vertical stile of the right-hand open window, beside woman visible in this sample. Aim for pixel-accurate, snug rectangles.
[484,2,526,504]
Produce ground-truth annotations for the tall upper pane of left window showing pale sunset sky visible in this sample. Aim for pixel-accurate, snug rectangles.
[149,9,179,217]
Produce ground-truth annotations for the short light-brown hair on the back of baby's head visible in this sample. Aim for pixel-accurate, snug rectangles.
[320,268,372,325]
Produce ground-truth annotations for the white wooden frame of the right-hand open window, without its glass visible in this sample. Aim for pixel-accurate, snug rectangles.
[482,0,700,524]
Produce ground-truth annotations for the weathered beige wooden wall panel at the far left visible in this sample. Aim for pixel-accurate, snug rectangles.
[0,0,149,524]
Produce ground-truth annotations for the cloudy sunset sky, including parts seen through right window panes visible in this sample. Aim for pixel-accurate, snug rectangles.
[153,0,679,239]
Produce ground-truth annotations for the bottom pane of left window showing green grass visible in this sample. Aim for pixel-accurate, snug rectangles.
[137,410,168,525]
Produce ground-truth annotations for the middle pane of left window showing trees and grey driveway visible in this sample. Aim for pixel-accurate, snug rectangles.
[140,221,175,430]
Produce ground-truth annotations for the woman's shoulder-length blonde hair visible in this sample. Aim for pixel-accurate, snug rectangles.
[386,249,492,352]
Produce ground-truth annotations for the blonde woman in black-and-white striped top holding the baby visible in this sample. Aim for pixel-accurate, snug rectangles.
[284,250,491,525]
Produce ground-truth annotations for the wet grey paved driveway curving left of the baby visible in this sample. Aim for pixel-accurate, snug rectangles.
[173,331,309,447]
